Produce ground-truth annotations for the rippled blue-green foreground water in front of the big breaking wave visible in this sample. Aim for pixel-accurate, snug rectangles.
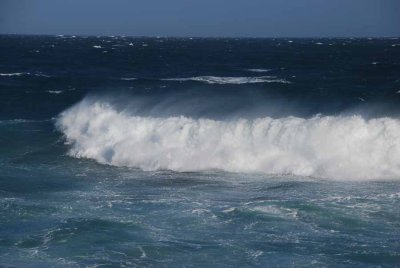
[0,149,400,267]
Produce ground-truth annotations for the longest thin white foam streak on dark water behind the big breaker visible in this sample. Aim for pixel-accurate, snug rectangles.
[161,76,290,85]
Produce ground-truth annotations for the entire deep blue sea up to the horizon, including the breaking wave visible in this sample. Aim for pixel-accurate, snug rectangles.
[0,35,400,267]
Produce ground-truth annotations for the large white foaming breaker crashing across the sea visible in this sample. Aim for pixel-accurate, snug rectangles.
[57,100,400,180]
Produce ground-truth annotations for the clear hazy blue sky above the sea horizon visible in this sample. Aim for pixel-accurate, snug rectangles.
[0,0,400,37]
